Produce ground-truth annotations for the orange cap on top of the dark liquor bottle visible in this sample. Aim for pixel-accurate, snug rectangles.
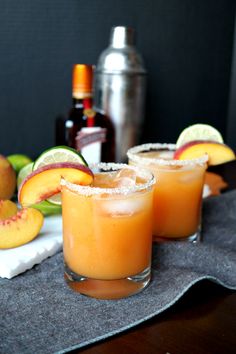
[72,64,93,99]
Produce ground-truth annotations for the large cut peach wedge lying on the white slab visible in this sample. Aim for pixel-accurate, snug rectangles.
[0,208,43,249]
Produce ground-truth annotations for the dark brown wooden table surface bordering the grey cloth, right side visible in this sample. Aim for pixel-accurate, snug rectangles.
[74,163,236,354]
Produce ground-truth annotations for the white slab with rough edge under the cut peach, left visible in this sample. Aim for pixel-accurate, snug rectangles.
[0,215,62,279]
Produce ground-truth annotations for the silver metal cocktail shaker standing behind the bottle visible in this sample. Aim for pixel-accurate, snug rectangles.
[94,26,146,162]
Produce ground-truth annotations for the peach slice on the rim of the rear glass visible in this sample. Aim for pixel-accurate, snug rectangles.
[174,140,235,166]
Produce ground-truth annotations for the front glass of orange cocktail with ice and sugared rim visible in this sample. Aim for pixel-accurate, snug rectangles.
[62,164,155,299]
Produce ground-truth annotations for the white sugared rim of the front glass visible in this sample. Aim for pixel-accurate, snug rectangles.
[61,162,156,196]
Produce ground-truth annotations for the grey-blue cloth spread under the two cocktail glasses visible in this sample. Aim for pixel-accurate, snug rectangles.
[0,191,236,354]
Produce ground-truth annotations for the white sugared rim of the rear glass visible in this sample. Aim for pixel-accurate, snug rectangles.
[127,143,208,166]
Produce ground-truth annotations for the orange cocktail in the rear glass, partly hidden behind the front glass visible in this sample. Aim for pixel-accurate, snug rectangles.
[128,144,207,241]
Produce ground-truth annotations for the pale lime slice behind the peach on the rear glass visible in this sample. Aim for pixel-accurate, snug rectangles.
[176,124,224,149]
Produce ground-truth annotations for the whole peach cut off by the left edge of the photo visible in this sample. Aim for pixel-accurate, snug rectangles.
[0,155,16,199]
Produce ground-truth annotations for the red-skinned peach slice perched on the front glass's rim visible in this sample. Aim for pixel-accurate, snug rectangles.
[18,162,93,207]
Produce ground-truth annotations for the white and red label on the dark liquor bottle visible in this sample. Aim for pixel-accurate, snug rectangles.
[76,127,107,163]
